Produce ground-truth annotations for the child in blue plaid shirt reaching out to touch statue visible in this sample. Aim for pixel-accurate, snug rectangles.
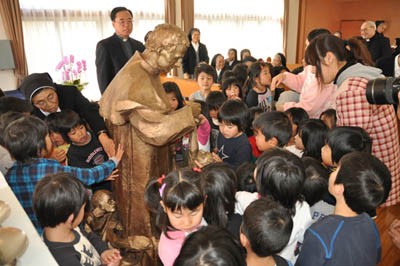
[3,116,124,234]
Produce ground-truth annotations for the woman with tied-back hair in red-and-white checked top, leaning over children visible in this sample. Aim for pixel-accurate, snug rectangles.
[305,34,400,206]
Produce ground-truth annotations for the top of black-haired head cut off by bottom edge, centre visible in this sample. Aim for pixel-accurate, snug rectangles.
[174,225,246,266]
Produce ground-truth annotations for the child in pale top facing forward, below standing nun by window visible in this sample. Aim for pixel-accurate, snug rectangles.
[189,63,217,101]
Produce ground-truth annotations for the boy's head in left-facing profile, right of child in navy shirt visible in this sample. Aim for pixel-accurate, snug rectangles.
[253,111,292,152]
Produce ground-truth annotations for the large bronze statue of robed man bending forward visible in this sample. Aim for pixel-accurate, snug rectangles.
[100,24,198,264]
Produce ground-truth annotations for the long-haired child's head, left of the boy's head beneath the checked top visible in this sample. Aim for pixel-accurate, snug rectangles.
[294,118,328,162]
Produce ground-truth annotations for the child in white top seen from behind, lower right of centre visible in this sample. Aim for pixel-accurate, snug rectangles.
[235,148,312,263]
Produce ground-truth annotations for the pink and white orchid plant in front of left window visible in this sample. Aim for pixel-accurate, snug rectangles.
[56,55,88,91]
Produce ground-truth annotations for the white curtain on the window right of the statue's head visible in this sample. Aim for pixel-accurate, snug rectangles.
[194,0,285,60]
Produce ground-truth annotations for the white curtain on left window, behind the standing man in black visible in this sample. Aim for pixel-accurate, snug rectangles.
[20,0,164,100]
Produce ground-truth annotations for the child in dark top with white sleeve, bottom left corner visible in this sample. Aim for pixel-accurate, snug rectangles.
[33,173,121,266]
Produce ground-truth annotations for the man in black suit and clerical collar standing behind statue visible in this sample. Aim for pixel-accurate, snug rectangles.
[96,7,144,94]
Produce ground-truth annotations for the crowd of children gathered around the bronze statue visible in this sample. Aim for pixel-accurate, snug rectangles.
[0,28,395,266]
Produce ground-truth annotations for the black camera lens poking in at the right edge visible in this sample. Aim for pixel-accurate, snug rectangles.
[365,77,400,104]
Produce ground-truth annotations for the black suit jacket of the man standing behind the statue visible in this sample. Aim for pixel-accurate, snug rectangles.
[96,34,145,94]
